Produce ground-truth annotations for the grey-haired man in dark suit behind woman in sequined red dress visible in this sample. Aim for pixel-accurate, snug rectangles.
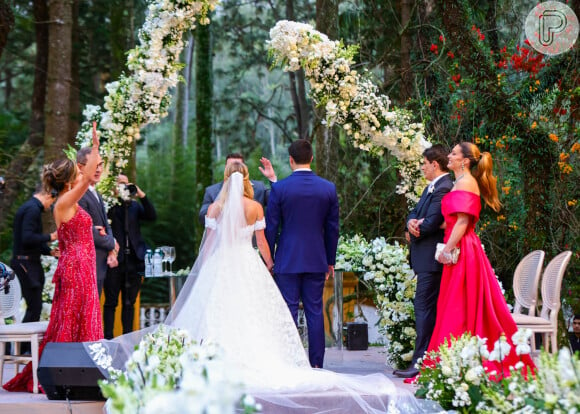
[77,147,119,297]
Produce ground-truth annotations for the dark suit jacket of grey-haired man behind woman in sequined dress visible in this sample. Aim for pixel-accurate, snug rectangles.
[79,190,115,282]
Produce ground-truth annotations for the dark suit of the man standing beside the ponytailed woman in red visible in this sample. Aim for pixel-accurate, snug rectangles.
[407,175,453,366]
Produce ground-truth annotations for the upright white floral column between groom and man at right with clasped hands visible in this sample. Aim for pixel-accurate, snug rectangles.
[362,237,417,368]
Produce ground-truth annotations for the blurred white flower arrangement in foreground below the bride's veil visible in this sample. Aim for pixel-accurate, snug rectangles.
[98,325,261,414]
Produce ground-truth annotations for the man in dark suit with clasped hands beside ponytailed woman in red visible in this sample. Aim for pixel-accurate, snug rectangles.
[394,145,453,378]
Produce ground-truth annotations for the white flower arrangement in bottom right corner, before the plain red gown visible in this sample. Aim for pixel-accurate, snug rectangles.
[410,329,580,414]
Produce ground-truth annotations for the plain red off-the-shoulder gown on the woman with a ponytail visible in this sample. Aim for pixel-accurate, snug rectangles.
[427,191,535,376]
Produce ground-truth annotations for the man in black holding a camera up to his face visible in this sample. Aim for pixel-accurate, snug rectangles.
[103,174,157,339]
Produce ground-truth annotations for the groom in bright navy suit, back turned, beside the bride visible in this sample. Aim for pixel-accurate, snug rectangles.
[266,139,338,368]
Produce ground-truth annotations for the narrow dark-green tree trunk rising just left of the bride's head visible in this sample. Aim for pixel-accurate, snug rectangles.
[195,25,213,206]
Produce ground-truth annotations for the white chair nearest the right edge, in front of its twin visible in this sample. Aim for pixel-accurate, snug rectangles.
[513,250,572,353]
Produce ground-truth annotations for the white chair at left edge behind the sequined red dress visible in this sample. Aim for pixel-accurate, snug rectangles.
[0,264,48,393]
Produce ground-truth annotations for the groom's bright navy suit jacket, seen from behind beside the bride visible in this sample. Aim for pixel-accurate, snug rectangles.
[265,170,339,274]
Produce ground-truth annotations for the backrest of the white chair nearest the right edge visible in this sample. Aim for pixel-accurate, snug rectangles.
[540,250,572,326]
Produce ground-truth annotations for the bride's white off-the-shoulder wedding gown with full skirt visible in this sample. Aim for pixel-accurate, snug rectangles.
[171,218,310,389]
